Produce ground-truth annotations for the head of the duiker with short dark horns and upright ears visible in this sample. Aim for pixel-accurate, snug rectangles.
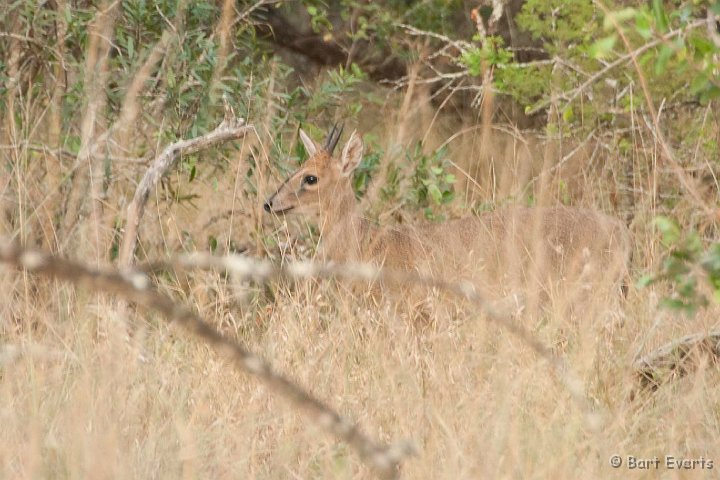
[264,125,363,214]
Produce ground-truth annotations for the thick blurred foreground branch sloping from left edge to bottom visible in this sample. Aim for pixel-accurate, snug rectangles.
[0,244,414,478]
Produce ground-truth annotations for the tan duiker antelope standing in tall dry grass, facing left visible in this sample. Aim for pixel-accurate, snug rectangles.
[264,128,630,302]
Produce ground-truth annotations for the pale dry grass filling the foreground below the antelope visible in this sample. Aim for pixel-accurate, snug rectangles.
[0,258,720,478]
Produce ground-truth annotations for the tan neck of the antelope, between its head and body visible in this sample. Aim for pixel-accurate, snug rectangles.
[319,179,368,262]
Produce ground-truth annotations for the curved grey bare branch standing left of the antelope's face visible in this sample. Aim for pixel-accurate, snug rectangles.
[118,118,253,267]
